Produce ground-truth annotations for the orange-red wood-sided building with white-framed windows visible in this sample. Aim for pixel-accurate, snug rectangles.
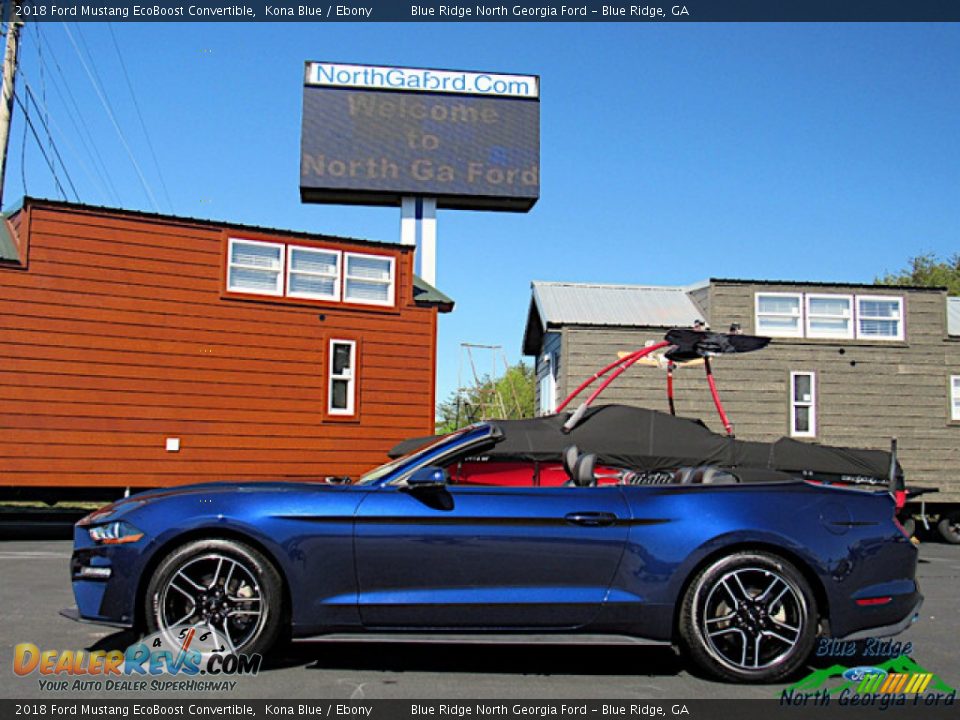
[0,198,453,496]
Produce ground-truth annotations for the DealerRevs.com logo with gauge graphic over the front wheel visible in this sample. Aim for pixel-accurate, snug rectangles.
[13,625,263,692]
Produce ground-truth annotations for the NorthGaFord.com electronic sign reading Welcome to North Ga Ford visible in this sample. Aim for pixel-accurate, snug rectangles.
[300,62,540,211]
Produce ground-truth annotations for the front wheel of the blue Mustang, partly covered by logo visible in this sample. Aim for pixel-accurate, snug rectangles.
[144,539,284,655]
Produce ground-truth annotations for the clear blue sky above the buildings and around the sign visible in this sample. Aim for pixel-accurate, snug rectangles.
[5,23,960,398]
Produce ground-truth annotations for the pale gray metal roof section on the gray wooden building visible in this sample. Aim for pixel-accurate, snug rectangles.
[532,282,705,327]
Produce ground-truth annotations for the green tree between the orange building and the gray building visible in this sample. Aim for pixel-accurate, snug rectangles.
[437,361,537,435]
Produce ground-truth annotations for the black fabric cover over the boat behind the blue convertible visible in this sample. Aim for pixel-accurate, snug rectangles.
[389,405,901,482]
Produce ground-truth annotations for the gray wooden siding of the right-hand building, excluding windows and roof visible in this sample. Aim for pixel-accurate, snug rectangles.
[544,281,960,502]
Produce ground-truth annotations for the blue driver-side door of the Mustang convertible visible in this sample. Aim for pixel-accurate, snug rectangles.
[355,485,629,629]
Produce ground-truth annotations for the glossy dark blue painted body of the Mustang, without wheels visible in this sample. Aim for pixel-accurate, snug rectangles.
[67,422,920,641]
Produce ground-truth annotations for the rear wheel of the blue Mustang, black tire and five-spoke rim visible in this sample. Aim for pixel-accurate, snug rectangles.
[678,551,818,683]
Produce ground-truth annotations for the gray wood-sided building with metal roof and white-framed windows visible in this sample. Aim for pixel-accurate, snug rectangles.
[523,279,960,502]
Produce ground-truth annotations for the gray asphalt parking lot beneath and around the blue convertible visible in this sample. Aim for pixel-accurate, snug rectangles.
[0,539,960,700]
